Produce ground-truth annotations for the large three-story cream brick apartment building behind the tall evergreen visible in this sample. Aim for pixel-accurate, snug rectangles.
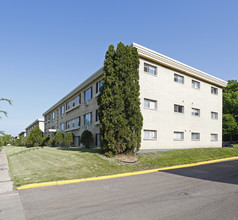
[43,43,227,149]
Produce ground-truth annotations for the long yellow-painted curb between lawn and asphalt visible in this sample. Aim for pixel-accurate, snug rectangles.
[17,156,238,190]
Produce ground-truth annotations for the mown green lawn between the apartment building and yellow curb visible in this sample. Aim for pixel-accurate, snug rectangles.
[6,145,238,187]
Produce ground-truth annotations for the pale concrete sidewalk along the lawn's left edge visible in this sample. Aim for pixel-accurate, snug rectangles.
[0,147,26,220]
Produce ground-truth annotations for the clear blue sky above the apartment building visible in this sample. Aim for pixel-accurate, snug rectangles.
[0,0,238,136]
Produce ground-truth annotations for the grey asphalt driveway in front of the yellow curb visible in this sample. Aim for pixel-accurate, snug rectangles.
[19,160,238,220]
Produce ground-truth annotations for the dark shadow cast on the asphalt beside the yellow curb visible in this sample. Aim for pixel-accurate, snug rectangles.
[163,160,238,184]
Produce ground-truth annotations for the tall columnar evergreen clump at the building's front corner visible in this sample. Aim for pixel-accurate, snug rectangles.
[98,43,143,155]
